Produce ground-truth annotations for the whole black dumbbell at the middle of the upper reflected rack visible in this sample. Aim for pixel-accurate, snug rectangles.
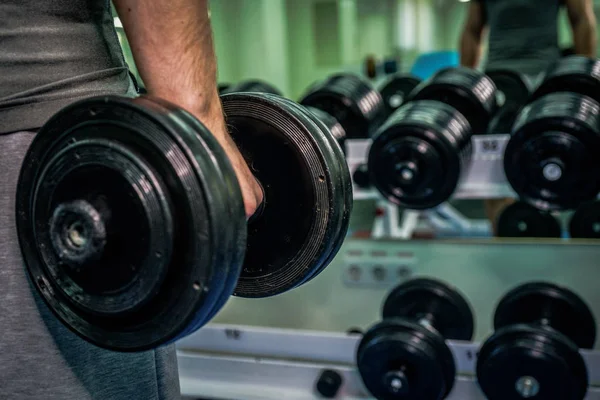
[368,68,496,209]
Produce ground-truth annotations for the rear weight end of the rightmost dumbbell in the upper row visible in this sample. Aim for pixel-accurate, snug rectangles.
[533,56,600,103]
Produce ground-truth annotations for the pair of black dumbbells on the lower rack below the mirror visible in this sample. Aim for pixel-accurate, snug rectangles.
[356,278,596,400]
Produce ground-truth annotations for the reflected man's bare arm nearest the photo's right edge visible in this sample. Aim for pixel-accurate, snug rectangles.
[565,0,596,57]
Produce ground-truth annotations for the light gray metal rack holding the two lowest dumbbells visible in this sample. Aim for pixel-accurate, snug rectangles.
[177,324,600,400]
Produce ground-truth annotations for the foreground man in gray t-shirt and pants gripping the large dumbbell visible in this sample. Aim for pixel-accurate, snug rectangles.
[0,0,262,400]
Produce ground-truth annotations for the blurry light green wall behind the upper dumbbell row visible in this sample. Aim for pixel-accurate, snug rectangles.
[119,0,600,99]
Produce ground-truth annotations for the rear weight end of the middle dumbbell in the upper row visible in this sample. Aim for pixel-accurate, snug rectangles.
[409,67,497,134]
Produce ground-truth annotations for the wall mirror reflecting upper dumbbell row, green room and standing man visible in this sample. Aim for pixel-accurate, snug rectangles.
[117,0,600,240]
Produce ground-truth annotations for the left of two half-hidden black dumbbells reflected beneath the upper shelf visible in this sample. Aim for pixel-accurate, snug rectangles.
[497,201,562,238]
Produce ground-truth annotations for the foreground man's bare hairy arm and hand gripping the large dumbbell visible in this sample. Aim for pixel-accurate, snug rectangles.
[113,0,262,216]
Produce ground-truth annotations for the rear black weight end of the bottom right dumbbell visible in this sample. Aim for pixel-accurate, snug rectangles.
[494,282,596,349]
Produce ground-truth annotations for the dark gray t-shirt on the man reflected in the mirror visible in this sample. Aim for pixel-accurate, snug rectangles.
[476,0,562,76]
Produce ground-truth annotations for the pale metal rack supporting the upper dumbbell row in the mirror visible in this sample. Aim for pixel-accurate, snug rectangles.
[346,135,516,239]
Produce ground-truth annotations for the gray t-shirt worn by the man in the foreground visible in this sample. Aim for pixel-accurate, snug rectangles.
[0,0,135,134]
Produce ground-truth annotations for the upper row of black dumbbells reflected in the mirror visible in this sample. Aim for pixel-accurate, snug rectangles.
[225,56,600,216]
